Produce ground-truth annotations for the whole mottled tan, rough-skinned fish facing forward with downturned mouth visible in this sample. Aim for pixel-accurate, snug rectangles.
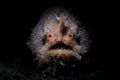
[27,7,89,63]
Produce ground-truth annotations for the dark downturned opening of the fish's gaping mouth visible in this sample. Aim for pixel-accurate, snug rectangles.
[49,42,73,51]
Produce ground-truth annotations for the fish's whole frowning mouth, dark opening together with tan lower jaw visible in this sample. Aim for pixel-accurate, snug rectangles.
[41,42,81,62]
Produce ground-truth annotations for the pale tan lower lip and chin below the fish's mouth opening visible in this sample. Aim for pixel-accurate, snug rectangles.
[40,49,81,62]
